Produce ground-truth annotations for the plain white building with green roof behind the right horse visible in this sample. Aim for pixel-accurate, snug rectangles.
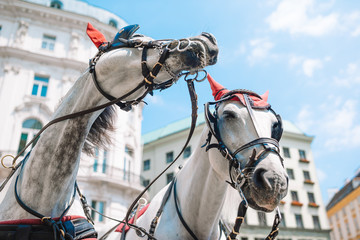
[141,114,330,240]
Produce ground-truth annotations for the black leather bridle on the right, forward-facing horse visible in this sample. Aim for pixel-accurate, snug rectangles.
[202,90,284,240]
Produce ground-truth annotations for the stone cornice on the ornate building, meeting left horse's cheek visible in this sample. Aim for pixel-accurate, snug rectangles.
[0,47,88,72]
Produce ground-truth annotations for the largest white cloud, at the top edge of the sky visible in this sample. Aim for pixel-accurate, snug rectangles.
[266,0,339,36]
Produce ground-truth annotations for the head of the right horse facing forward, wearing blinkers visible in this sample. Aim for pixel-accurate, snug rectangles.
[205,76,288,212]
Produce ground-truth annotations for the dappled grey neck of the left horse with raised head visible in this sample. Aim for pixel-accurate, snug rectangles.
[0,73,106,219]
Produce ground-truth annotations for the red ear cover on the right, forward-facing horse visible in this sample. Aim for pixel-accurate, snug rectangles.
[207,74,270,108]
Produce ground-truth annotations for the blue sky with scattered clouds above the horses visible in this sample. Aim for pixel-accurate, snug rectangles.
[81,0,360,203]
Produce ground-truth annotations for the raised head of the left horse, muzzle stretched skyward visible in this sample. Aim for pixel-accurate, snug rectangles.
[87,25,218,100]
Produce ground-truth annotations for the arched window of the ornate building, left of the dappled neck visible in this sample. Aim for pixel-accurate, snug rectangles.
[18,118,42,156]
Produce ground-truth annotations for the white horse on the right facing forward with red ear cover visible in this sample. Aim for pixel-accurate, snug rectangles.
[109,76,288,240]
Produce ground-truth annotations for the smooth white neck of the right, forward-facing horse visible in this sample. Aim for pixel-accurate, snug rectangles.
[177,127,227,239]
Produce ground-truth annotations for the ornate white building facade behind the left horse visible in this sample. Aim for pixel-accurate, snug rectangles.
[0,0,143,232]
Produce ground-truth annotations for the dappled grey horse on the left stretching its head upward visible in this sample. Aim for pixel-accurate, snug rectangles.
[0,23,218,239]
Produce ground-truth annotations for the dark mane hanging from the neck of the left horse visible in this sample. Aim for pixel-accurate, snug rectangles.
[82,106,116,155]
